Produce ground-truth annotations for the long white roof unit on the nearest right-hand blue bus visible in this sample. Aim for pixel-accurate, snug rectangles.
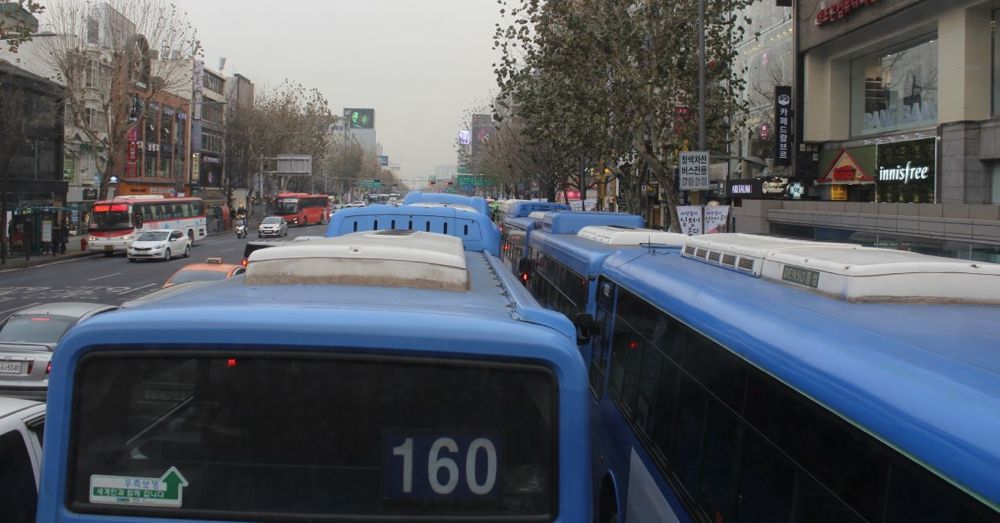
[683,234,1000,304]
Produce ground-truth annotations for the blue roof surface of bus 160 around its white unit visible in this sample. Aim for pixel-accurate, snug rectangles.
[60,246,576,353]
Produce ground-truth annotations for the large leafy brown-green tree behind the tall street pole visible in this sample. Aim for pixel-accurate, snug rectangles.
[494,0,752,230]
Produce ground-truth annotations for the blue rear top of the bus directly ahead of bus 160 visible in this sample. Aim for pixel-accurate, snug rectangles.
[326,205,500,256]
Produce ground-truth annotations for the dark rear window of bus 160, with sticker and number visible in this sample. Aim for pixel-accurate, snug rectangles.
[68,352,558,521]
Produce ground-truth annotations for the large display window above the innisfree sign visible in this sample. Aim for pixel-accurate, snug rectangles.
[851,34,938,136]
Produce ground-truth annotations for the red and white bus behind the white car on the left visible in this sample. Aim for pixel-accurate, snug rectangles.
[87,195,208,256]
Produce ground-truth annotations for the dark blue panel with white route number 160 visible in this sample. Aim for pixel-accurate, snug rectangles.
[382,432,503,501]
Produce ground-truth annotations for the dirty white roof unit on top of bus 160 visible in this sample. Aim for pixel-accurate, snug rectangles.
[245,230,469,291]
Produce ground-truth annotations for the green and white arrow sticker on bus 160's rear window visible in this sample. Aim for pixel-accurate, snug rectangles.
[90,467,188,508]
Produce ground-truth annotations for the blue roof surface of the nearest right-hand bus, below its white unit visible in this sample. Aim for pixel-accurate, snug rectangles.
[604,251,1000,507]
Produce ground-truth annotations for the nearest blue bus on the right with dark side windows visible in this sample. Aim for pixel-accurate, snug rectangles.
[590,234,1000,522]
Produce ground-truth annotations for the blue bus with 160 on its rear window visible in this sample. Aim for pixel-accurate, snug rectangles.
[38,230,592,523]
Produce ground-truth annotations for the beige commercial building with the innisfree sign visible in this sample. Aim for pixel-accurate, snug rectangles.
[730,0,1000,261]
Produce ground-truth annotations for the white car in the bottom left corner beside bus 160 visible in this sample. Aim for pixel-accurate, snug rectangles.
[0,398,45,523]
